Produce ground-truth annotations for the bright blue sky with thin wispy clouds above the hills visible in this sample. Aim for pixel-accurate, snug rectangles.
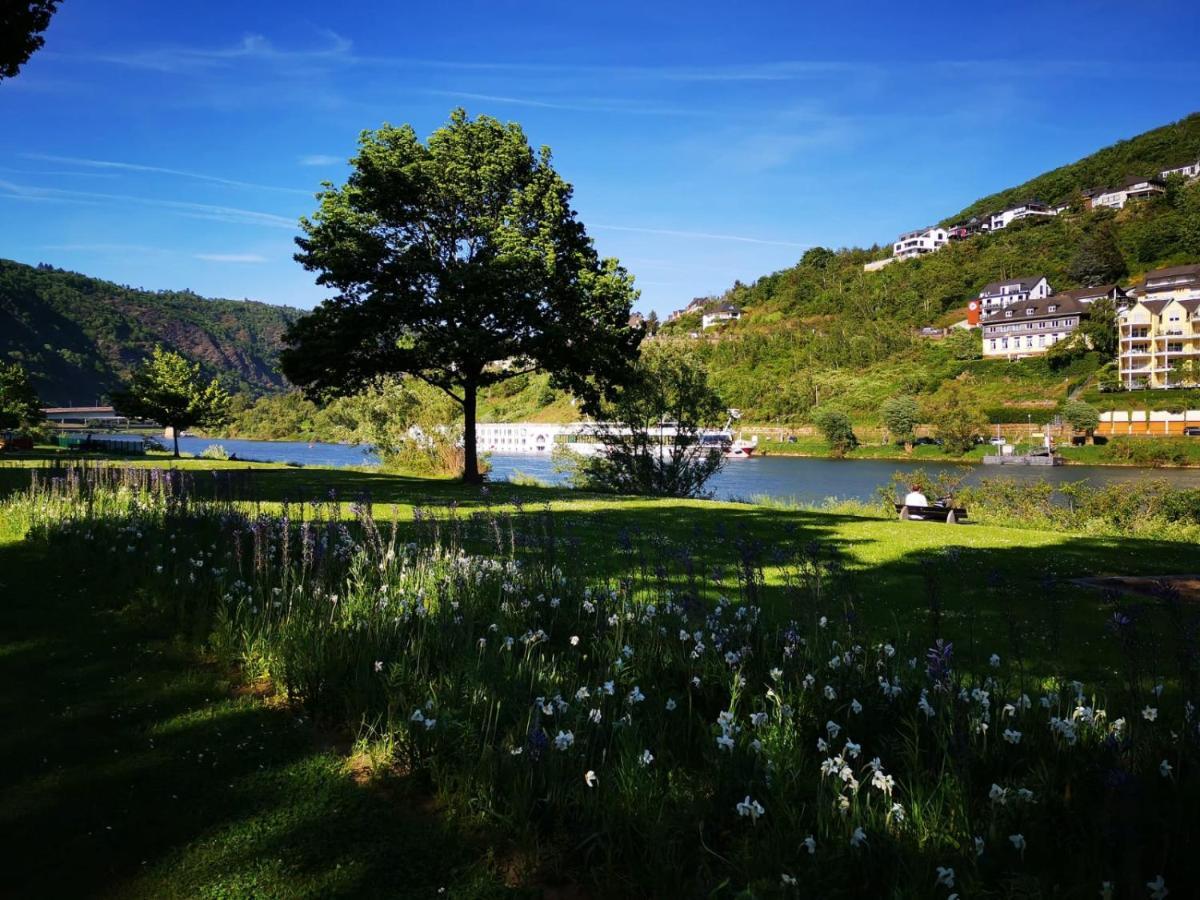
[0,0,1200,313]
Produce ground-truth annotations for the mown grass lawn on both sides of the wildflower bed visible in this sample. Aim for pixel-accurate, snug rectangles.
[0,455,1200,896]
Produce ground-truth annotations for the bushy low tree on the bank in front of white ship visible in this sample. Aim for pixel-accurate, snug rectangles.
[560,344,726,497]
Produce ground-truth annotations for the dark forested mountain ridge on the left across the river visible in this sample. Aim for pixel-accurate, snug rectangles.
[0,259,302,404]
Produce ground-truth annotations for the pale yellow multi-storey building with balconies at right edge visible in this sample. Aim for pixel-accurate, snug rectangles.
[1117,300,1200,390]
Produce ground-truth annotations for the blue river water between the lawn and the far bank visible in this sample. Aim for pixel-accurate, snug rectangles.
[164,438,1200,504]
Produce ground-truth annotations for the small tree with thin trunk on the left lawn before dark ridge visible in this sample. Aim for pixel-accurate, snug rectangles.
[113,347,230,457]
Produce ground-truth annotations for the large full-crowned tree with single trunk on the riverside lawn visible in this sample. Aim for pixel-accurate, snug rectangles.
[281,109,643,481]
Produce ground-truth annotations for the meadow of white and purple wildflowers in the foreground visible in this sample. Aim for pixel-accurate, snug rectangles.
[4,467,1200,900]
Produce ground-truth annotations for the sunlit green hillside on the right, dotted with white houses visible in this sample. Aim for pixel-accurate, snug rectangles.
[660,116,1200,422]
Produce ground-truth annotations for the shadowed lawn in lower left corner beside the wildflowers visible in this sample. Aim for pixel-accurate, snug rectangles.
[0,545,516,896]
